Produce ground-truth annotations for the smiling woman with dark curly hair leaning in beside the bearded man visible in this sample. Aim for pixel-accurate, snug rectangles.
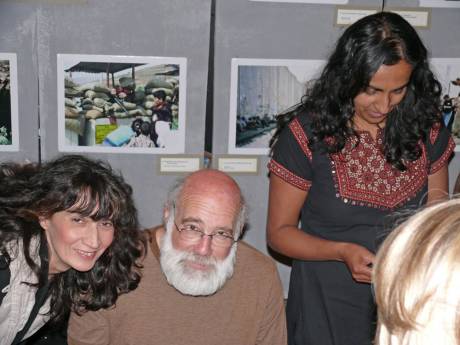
[0,155,144,345]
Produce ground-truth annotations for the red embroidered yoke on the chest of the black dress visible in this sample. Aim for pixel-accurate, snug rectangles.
[329,132,428,209]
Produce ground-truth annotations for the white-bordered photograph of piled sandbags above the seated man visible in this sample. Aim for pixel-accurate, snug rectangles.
[57,54,187,154]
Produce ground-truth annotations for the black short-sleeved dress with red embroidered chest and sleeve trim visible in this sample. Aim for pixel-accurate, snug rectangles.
[269,116,455,345]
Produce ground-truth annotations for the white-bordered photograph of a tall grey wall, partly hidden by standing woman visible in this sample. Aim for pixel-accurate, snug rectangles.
[228,58,325,155]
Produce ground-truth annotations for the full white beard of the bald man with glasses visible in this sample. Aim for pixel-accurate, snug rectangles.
[160,217,237,296]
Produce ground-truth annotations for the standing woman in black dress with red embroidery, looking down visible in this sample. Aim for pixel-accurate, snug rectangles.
[267,12,455,345]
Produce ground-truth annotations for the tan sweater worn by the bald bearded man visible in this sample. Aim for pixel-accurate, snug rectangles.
[68,228,287,345]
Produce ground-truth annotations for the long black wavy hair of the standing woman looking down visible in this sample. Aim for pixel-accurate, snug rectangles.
[271,12,441,170]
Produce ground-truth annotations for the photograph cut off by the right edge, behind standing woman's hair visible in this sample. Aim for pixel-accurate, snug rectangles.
[430,58,460,151]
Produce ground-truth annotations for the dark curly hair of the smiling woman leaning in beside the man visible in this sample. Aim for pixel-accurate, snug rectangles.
[0,155,145,322]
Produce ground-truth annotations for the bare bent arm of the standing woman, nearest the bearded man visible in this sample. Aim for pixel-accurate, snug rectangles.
[267,174,374,283]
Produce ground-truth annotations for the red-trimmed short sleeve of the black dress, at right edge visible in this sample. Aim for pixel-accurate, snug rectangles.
[427,123,455,175]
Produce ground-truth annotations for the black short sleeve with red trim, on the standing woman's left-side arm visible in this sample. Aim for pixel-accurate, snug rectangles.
[268,118,312,190]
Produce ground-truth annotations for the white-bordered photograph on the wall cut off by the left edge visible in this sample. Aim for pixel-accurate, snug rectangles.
[0,53,19,151]
